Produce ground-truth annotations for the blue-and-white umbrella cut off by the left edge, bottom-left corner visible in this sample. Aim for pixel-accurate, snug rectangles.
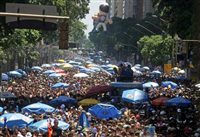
[0,113,33,129]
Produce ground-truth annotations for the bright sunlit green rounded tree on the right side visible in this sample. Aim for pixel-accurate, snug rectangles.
[138,35,175,65]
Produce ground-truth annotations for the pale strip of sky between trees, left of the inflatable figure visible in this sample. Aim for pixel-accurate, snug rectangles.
[82,0,105,36]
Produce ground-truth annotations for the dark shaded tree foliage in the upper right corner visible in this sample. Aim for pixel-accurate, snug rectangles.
[153,0,193,39]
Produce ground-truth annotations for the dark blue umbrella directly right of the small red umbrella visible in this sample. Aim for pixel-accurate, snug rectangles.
[166,97,191,107]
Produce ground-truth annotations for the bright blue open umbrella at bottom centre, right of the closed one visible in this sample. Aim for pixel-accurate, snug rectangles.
[89,103,121,120]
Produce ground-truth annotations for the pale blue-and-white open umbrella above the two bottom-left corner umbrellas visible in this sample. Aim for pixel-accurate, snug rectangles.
[22,102,55,114]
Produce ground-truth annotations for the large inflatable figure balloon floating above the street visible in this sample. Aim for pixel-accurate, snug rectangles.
[92,3,112,31]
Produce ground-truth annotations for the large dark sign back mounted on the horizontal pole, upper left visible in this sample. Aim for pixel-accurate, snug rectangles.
[6,3,58,30]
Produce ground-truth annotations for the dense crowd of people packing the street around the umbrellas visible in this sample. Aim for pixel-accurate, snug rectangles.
[0,61,200,137]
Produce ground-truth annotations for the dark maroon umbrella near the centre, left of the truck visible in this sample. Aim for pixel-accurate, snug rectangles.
[85,85,114,96]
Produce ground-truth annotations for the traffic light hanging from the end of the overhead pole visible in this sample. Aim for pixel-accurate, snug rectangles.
[59,21,69,49]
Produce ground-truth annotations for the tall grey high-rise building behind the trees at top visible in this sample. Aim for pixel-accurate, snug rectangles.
[106,0,154,20]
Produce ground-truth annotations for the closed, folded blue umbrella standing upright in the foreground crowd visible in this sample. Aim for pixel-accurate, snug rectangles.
[77,112,90,129]
